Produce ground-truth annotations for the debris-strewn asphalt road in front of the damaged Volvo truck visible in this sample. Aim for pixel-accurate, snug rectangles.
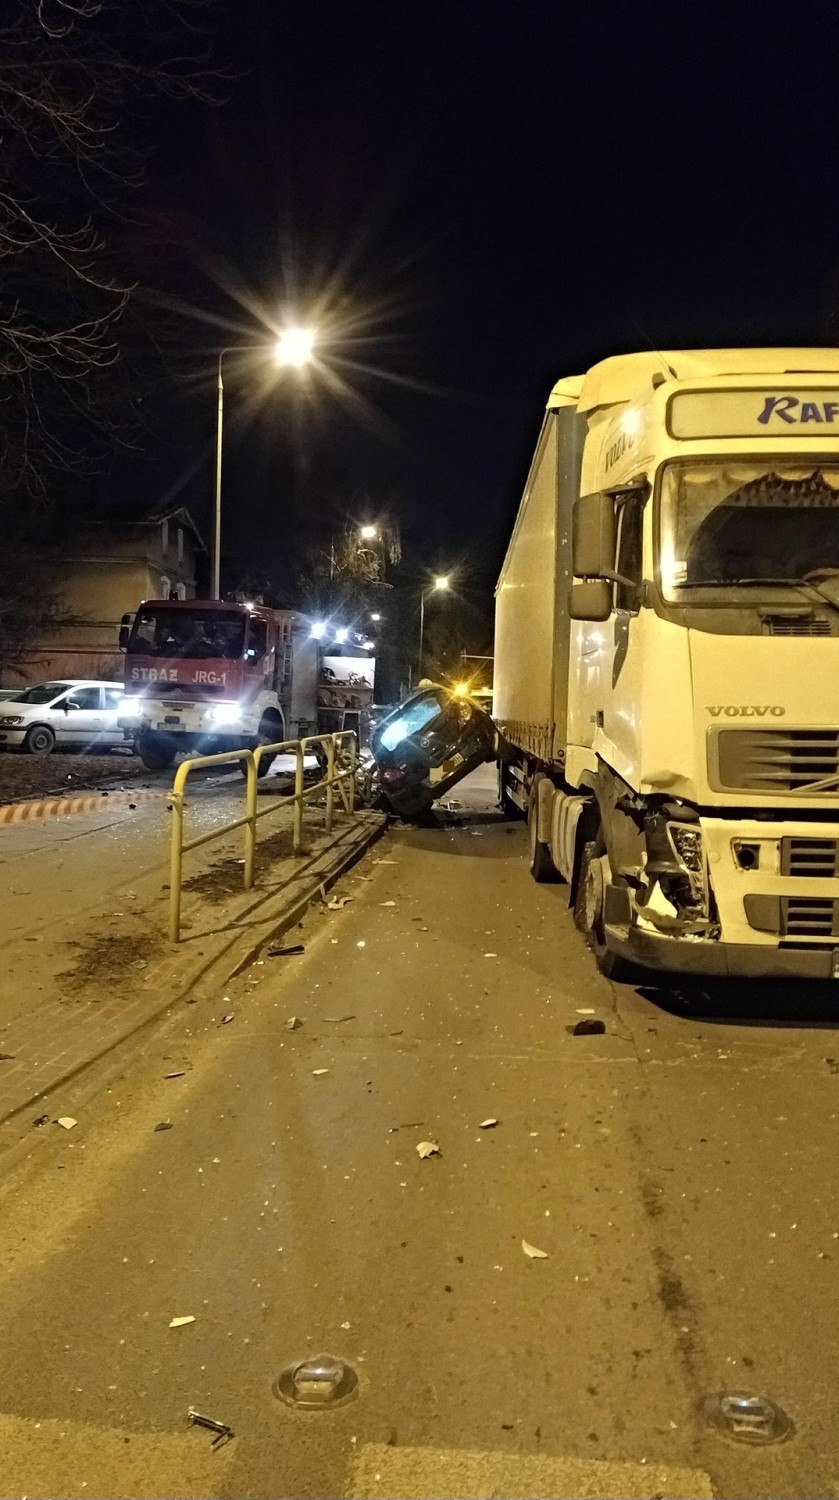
[0,776,839,1497]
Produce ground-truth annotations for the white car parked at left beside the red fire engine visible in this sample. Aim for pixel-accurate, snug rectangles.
[0,678,126,755]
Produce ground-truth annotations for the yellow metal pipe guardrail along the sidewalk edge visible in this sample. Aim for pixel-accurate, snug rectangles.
[170,729,359,942]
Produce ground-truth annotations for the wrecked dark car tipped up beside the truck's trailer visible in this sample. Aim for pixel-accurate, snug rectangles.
[371,687,495,818]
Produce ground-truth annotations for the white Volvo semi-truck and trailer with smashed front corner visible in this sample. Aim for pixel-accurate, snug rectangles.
[495,348,839,978]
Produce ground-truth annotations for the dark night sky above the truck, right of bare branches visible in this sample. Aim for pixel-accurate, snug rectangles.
[134,0,839,627]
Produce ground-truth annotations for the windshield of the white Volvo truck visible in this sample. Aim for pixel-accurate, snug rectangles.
[659,458,839,599]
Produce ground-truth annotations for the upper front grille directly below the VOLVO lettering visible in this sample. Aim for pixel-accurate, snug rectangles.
[711,729,839,797]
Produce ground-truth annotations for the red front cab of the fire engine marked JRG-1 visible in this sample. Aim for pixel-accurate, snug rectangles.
[120,599,293,771]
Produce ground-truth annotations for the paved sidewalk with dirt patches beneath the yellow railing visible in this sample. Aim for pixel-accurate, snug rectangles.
[0,810,386,1122]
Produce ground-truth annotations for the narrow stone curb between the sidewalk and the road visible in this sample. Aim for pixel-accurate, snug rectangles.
[0,816,390,1128]
